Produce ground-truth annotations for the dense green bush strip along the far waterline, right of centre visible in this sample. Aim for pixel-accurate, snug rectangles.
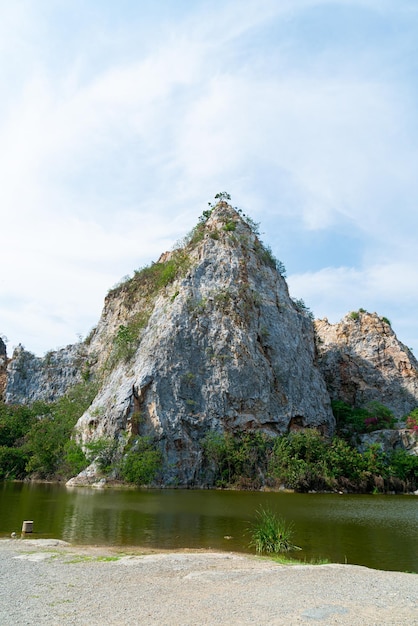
[203,429,418,492]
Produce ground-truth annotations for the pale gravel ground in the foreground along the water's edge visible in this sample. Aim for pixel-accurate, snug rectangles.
[0,539,418,626]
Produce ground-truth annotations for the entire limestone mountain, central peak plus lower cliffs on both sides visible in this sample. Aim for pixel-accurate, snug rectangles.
[0,200,418,485]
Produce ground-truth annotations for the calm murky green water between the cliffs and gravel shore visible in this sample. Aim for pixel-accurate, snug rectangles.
[0,482,418,572]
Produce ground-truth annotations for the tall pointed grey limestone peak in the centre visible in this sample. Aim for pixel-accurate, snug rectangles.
[71,203,334,484]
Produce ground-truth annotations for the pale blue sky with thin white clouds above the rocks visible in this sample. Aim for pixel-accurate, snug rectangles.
[0,0,418,355]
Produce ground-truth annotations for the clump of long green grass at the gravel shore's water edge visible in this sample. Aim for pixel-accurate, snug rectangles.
[249,508,301,554]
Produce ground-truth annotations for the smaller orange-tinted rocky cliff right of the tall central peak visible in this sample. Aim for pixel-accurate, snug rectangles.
[315,311,418,419]
